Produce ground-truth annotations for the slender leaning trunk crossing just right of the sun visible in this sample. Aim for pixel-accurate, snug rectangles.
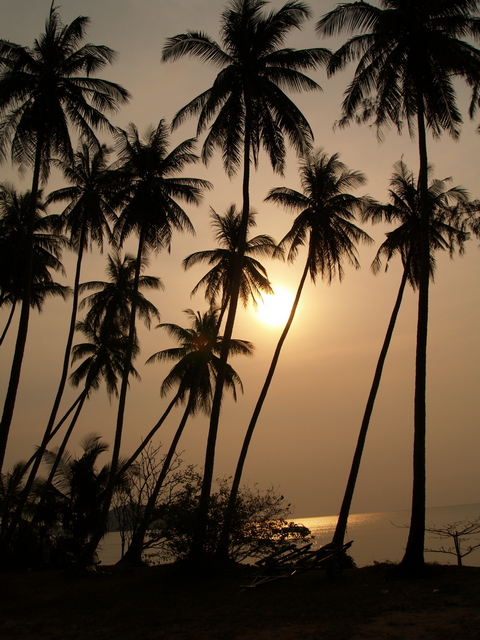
[217,262,309,558]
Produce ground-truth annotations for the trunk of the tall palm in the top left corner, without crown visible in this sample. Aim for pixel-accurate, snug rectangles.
[0,132,43,477]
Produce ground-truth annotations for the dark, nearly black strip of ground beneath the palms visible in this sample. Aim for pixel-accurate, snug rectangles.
[0,564,480,640]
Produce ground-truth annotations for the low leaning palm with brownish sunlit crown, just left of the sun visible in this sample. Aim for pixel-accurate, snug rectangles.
[122,309,253,563]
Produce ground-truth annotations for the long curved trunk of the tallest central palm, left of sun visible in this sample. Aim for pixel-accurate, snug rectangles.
[190,110,251,562]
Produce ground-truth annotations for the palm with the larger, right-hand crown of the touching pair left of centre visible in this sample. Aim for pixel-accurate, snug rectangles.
[86,120,211,552]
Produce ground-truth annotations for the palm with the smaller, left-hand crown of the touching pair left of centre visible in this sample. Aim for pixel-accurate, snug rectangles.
[39,142,116,459]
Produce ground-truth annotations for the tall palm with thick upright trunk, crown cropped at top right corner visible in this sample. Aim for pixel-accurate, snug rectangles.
[317,0,480,572]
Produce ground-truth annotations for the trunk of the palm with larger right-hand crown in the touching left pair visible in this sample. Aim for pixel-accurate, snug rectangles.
[85,228,144,563]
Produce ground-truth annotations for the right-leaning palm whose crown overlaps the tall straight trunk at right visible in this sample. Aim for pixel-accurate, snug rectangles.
[332,160,468,546]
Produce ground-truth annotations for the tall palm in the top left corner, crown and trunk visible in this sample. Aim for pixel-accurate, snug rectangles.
[0,3,129,470]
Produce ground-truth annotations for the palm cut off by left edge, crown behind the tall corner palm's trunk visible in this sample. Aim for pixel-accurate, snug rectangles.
[0,184,70,344]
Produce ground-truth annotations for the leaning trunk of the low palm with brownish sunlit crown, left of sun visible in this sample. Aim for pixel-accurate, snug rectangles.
[120,394,193,564]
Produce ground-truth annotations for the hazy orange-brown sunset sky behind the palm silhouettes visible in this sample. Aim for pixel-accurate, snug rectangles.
[0,0,480,518]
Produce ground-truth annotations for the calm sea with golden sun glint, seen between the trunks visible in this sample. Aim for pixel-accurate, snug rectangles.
[95,503,480,567]
